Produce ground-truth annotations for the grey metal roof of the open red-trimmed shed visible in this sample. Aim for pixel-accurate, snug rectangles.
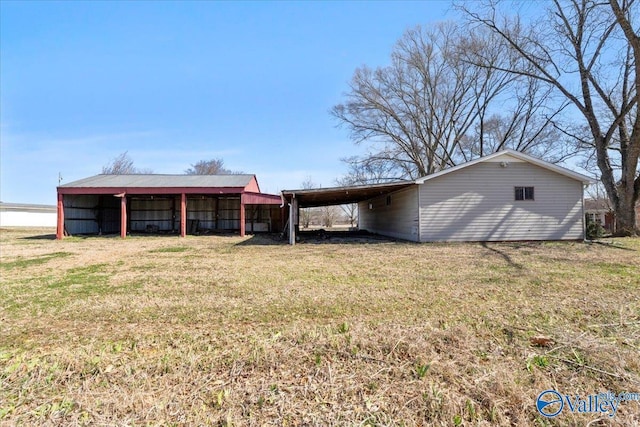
[59,174,255,188]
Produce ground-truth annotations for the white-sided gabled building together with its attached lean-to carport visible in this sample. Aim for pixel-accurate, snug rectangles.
[282,150,593,243]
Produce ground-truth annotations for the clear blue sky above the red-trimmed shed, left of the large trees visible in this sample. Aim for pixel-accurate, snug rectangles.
[0,1,450,204]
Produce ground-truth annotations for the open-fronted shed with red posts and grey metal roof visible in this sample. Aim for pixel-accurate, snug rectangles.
[57,174,284,239]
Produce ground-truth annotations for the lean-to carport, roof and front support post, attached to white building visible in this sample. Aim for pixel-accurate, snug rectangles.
[282,181,415,245]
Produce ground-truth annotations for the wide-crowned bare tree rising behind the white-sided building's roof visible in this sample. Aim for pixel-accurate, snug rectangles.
[332,23,554,180]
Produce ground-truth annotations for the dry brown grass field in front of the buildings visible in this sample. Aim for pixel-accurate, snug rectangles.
[0,230,640,426]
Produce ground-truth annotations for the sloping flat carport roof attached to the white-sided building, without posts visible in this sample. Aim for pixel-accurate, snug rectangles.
[282,181,415,208]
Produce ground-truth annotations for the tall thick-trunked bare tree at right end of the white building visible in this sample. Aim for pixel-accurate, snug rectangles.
[460,0,640,235]
